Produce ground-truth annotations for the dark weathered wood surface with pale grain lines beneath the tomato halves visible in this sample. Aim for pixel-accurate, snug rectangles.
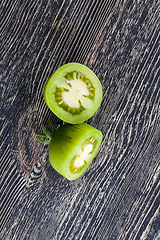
[0,0,160,240]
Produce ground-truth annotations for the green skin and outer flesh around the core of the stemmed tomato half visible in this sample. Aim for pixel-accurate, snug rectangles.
[49,123,103,180]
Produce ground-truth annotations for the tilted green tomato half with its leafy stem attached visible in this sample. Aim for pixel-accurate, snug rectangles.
[36,123,103,180]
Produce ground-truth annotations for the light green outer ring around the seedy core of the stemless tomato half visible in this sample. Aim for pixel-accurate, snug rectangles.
[43,63,103,124]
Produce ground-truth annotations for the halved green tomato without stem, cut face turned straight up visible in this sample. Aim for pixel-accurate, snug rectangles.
[43,63,102,124]
